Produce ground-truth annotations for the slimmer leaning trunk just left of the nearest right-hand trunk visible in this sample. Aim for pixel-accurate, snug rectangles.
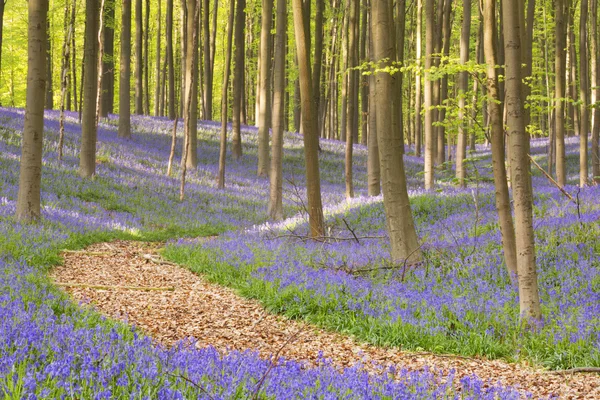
[483,0,517,280]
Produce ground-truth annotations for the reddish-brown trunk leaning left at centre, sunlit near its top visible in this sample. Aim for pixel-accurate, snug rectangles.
[292,0,325,238]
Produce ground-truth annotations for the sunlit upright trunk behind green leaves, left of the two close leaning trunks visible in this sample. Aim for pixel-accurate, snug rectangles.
[456,0,472,187]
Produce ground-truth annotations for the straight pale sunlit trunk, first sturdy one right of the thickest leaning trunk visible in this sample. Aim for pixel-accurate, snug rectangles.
[424,0,435,190]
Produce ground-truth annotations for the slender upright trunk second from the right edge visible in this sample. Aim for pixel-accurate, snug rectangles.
[579,0,597,187]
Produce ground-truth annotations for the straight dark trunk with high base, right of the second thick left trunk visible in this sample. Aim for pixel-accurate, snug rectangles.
[118,0,131,138]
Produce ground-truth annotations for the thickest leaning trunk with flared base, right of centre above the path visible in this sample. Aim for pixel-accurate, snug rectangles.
[371,0,421,263]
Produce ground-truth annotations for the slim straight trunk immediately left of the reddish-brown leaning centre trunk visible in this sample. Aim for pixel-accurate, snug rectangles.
[268,0,287,221]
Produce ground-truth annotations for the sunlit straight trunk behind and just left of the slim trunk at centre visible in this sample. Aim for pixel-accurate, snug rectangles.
[257,0,273,176]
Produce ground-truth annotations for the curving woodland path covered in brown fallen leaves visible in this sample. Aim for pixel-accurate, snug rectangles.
[51,239,600,399]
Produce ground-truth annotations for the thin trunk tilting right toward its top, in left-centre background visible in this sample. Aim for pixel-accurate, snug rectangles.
[215,0,235,189]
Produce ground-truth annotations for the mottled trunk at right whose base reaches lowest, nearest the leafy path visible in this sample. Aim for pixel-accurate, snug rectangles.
[502,0,542,323]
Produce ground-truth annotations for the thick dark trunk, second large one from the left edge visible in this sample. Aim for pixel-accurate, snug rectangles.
[79,0,100,178]
